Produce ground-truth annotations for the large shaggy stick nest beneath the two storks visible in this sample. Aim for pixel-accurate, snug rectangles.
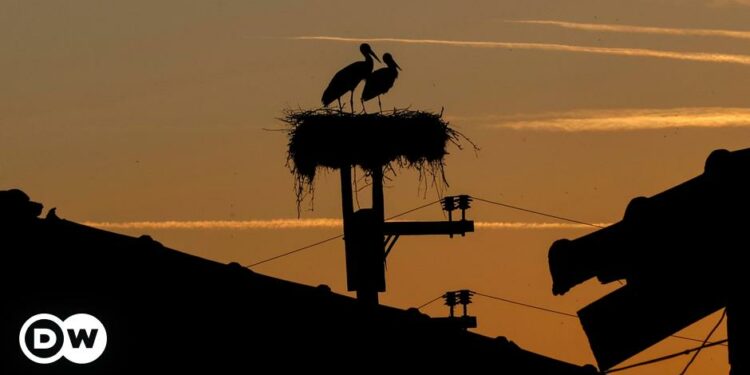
[281,108,477,212]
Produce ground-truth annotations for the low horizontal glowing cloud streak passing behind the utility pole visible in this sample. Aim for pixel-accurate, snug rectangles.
[83,219,609,230]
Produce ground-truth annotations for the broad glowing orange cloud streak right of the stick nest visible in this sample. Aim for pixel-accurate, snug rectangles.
[458,107,750,132]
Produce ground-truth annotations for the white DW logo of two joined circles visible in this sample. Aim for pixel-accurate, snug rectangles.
[18,314,107,364]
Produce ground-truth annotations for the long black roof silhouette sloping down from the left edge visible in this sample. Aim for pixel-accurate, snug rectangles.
[0,190,597,374]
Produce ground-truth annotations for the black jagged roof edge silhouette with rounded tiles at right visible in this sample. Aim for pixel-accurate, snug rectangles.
[549,149,750,375]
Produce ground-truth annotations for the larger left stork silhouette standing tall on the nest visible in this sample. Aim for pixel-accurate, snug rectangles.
[321,43,380,113]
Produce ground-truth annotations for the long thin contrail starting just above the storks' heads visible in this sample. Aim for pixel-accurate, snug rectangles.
[288,36,750,65]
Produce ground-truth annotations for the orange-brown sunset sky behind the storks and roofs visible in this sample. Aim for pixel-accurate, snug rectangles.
[0,0,750,374]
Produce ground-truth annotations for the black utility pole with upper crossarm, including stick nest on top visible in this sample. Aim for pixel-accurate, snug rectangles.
[282,108,476,304]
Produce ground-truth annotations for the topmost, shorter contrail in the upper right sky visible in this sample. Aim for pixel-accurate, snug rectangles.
[505,20,750,39]
